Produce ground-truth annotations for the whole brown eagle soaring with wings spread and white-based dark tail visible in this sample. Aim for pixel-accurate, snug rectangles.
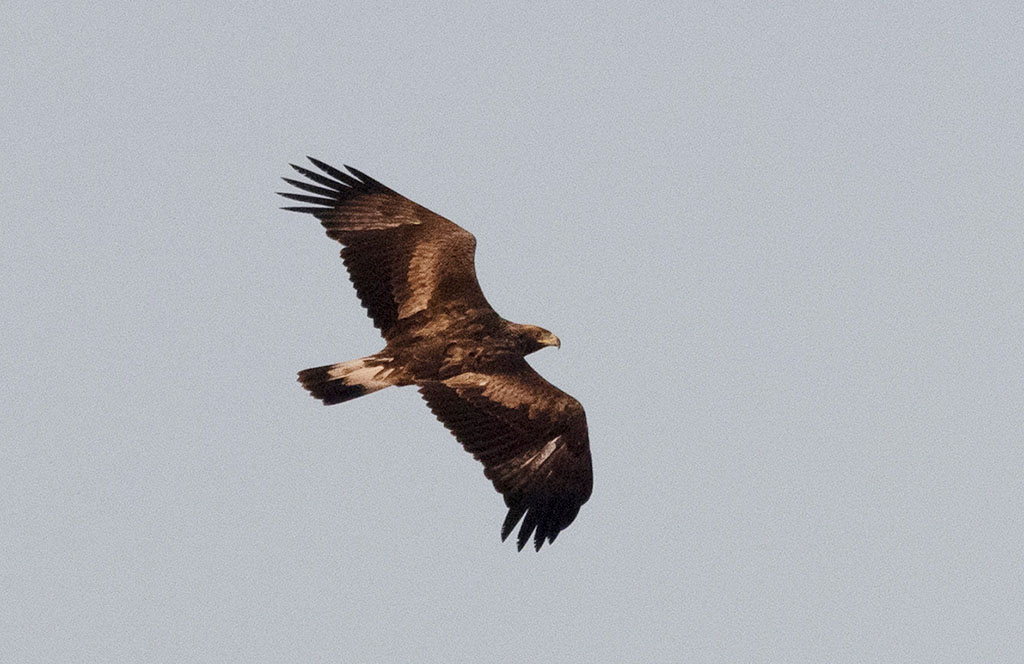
[279,157,593,550]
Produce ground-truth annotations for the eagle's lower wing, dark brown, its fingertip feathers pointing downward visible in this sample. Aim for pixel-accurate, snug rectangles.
[420,360,594,550]
